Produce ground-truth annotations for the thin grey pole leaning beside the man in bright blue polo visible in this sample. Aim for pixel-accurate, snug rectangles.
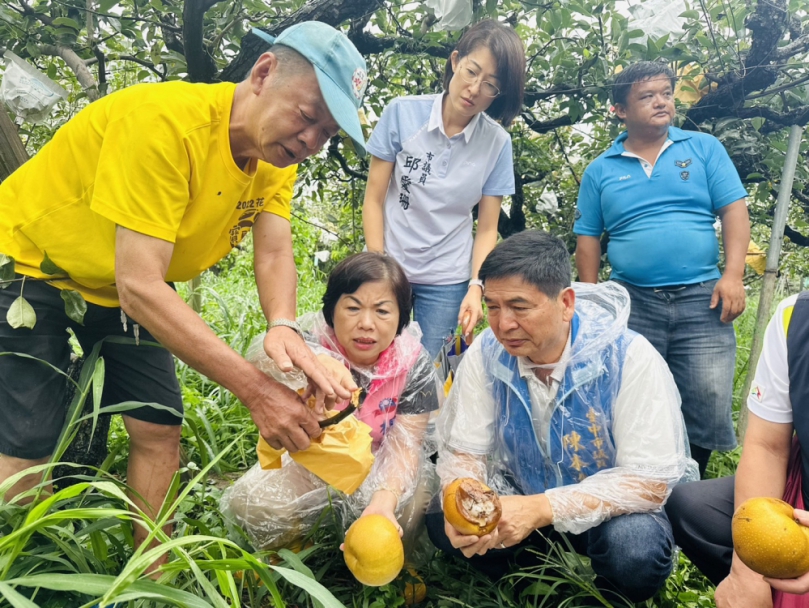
[736,125,803,442]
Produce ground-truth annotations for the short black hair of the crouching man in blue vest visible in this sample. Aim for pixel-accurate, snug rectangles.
[478,230,572,298]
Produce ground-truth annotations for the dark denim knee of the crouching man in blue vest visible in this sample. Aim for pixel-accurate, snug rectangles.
[588,513,674,602]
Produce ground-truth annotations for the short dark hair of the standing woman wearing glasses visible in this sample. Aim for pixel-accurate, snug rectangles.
[444,19,525,127]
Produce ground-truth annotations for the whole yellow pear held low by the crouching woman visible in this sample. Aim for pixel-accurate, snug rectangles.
[343,515,404,587]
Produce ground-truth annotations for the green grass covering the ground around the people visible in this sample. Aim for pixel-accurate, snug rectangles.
[0,235,772,608]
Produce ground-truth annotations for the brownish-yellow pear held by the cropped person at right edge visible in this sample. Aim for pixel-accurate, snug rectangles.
[732,497,809,578]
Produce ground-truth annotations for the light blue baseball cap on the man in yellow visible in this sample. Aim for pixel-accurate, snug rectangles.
[253,21,368,157]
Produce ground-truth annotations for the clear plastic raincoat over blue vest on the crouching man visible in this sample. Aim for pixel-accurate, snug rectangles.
[436,282,698,534]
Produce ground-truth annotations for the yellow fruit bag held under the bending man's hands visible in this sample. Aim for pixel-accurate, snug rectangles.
[256,416,374,494]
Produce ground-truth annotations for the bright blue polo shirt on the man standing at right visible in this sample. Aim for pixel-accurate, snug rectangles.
[573,127,747,287]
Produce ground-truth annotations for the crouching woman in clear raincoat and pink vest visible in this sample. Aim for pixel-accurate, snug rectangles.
[221,252,439,550]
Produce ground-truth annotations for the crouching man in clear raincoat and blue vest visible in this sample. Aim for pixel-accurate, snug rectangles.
[428,231,697,602]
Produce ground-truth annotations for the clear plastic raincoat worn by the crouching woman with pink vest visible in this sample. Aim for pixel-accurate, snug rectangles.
[221,313,440,550]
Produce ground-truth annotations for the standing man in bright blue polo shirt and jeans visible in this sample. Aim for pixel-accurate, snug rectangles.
[573,62,750,480]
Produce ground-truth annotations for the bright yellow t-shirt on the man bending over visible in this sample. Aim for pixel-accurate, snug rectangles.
[0,82,297,307]
